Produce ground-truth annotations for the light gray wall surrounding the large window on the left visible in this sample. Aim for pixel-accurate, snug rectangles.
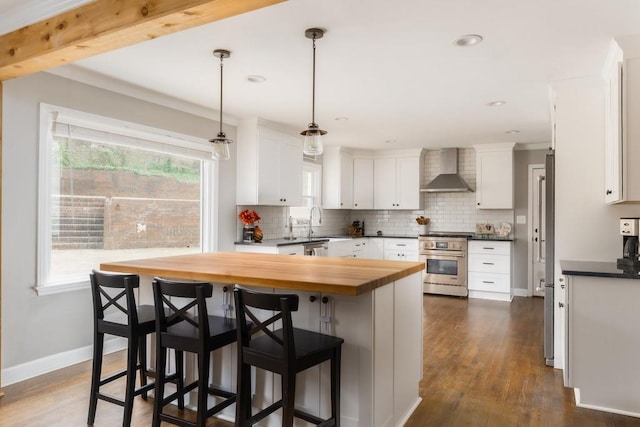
[2,73,236,369]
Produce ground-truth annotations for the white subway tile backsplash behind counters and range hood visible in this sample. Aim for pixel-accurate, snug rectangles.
[237,148,514,239]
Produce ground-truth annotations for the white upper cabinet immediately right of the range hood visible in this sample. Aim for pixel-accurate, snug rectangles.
[473,142,515,209]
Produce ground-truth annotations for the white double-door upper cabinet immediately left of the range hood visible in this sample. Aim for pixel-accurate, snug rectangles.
[373,149,423,210]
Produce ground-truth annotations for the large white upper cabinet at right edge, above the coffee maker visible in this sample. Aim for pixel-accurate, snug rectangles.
[602,37,640,203]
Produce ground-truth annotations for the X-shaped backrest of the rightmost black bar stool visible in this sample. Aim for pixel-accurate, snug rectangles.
[233,285,299,360]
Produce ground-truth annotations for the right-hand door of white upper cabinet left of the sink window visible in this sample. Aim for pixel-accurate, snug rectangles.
[272,142,302,206]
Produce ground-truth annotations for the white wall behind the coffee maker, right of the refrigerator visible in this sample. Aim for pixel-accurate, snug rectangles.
[553,78,640,368]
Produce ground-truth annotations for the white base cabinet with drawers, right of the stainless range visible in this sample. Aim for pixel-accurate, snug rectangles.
[467,240,513,301]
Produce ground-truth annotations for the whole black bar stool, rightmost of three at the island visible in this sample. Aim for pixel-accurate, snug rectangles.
[234,286,344,427]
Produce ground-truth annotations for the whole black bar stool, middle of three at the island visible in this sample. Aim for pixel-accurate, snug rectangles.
[152,277,237,427]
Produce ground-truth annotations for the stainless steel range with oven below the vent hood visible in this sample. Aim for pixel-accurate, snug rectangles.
[418,233,471,297]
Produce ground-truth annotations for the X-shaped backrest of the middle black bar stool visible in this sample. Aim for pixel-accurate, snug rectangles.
[152,277,213,342]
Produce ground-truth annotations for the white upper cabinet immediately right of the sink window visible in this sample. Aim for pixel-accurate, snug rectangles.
[322,147,353,209]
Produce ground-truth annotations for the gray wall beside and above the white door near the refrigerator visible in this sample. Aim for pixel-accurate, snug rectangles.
[513,150,547,289]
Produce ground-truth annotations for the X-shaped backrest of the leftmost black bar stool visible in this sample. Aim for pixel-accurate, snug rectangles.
[89,270,140,325]
